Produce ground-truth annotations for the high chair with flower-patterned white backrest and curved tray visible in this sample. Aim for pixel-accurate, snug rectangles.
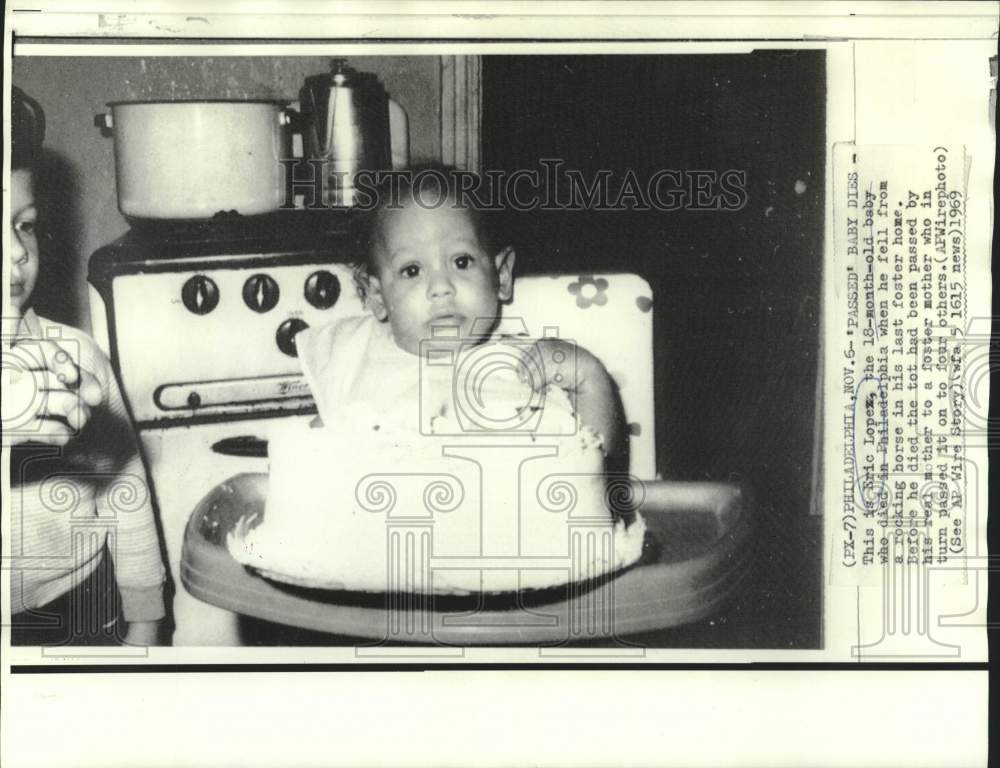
[181,273,752,653]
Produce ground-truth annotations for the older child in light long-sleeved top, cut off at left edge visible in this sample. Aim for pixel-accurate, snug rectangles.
[3,88,165,645]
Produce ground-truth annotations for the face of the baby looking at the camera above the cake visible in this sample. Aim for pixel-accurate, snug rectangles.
[370,198,514,354]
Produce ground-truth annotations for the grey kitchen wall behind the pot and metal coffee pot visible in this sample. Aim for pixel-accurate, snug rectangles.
[12,56,441,330]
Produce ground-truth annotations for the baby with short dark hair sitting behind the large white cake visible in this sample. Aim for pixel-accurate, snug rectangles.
[297,168,627,464]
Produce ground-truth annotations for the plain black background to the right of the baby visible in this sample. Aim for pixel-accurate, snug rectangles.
[482,51,826,646]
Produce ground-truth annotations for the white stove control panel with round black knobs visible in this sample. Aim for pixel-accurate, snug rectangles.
[98,254,366,426]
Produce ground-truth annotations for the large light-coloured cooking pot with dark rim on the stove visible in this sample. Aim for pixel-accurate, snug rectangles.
[95,100,295,219]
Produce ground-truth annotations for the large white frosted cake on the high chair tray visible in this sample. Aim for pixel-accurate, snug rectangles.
[228,348,645,594]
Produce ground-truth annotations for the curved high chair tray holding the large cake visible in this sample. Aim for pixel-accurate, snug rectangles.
[181,474,752,645]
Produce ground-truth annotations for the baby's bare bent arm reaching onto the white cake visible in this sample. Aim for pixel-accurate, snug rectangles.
[529,338,626,457]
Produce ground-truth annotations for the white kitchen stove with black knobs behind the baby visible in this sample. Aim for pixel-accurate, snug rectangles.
[88,210,364,646]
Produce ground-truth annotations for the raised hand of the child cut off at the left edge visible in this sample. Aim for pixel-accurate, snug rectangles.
[3,339,104,446]
